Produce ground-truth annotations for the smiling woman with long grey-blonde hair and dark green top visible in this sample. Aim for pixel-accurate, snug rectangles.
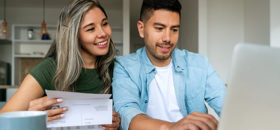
[1,0,120,129]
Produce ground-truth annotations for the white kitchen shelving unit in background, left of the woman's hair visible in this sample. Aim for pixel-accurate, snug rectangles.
[12,24,56,85]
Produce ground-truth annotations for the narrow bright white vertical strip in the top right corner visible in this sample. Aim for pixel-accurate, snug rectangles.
[270,0,280,47]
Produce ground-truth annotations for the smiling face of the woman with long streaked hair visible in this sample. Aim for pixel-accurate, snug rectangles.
[79,7,112,58]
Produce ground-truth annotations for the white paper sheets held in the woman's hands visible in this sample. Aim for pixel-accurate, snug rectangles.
[46,90,112,128]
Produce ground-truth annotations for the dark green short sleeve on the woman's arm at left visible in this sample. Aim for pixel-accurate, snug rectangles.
[29,58,56,90]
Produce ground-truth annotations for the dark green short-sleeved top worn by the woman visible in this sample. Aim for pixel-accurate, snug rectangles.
[29,58,113,93]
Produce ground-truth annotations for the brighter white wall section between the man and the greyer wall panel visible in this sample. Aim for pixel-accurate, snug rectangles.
[207,0,244,83]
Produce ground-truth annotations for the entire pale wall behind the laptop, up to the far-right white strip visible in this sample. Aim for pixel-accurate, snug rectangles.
[205,0,270,83]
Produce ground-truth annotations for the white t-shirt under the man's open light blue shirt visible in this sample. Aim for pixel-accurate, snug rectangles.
[146,62,183,122]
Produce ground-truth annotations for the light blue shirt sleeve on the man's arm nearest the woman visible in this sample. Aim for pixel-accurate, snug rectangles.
[112,61,143,130]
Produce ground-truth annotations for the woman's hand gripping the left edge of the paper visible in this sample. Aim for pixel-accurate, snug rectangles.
[28,96,67,121]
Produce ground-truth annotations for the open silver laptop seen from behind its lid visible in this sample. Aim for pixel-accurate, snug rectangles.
[218,44,280,130]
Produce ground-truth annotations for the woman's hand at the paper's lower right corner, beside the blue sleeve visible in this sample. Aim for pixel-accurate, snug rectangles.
[101,111,121,130]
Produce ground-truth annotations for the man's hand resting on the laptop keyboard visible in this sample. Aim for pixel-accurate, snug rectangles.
[163,112,218,130]
